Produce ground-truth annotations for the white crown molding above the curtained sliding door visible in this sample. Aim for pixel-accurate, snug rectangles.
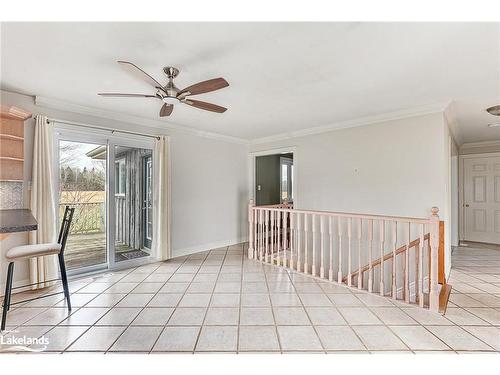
[35,95,249,145]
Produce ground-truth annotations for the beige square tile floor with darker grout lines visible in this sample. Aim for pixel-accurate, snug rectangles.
[0,245,500,353]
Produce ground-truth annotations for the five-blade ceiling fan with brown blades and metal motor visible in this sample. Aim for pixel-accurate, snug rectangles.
[97,61,229,117]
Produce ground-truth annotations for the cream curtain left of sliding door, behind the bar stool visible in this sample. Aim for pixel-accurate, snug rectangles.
[29,115,58,287]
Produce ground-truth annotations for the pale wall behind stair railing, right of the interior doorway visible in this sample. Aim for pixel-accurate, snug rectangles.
[251,113,447,217]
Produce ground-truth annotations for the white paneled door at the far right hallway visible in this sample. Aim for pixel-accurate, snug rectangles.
[464,156,500,243]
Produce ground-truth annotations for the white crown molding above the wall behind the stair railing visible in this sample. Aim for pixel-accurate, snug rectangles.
[250,102,449,145]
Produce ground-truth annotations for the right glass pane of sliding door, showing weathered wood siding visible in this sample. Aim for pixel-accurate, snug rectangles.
[114,145,152,263]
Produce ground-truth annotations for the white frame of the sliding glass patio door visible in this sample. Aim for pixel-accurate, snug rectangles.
[52,121,158,276]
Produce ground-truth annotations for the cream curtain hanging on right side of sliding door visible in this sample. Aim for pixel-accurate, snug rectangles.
[152,136,172,260]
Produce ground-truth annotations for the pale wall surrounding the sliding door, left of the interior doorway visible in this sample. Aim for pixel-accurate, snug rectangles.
[0,91,248,285]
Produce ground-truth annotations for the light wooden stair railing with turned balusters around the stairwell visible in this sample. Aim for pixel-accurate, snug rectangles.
[248,201,444,311]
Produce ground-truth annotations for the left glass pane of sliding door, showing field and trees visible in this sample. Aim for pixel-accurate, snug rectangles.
[58,140,108,270]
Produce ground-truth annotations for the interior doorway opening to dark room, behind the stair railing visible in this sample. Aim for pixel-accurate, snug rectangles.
[254,152,294,206]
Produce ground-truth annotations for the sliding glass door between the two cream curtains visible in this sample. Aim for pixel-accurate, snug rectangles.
[56,130,154,273]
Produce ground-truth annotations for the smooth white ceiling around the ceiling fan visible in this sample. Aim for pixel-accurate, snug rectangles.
[0,23,500,143]
